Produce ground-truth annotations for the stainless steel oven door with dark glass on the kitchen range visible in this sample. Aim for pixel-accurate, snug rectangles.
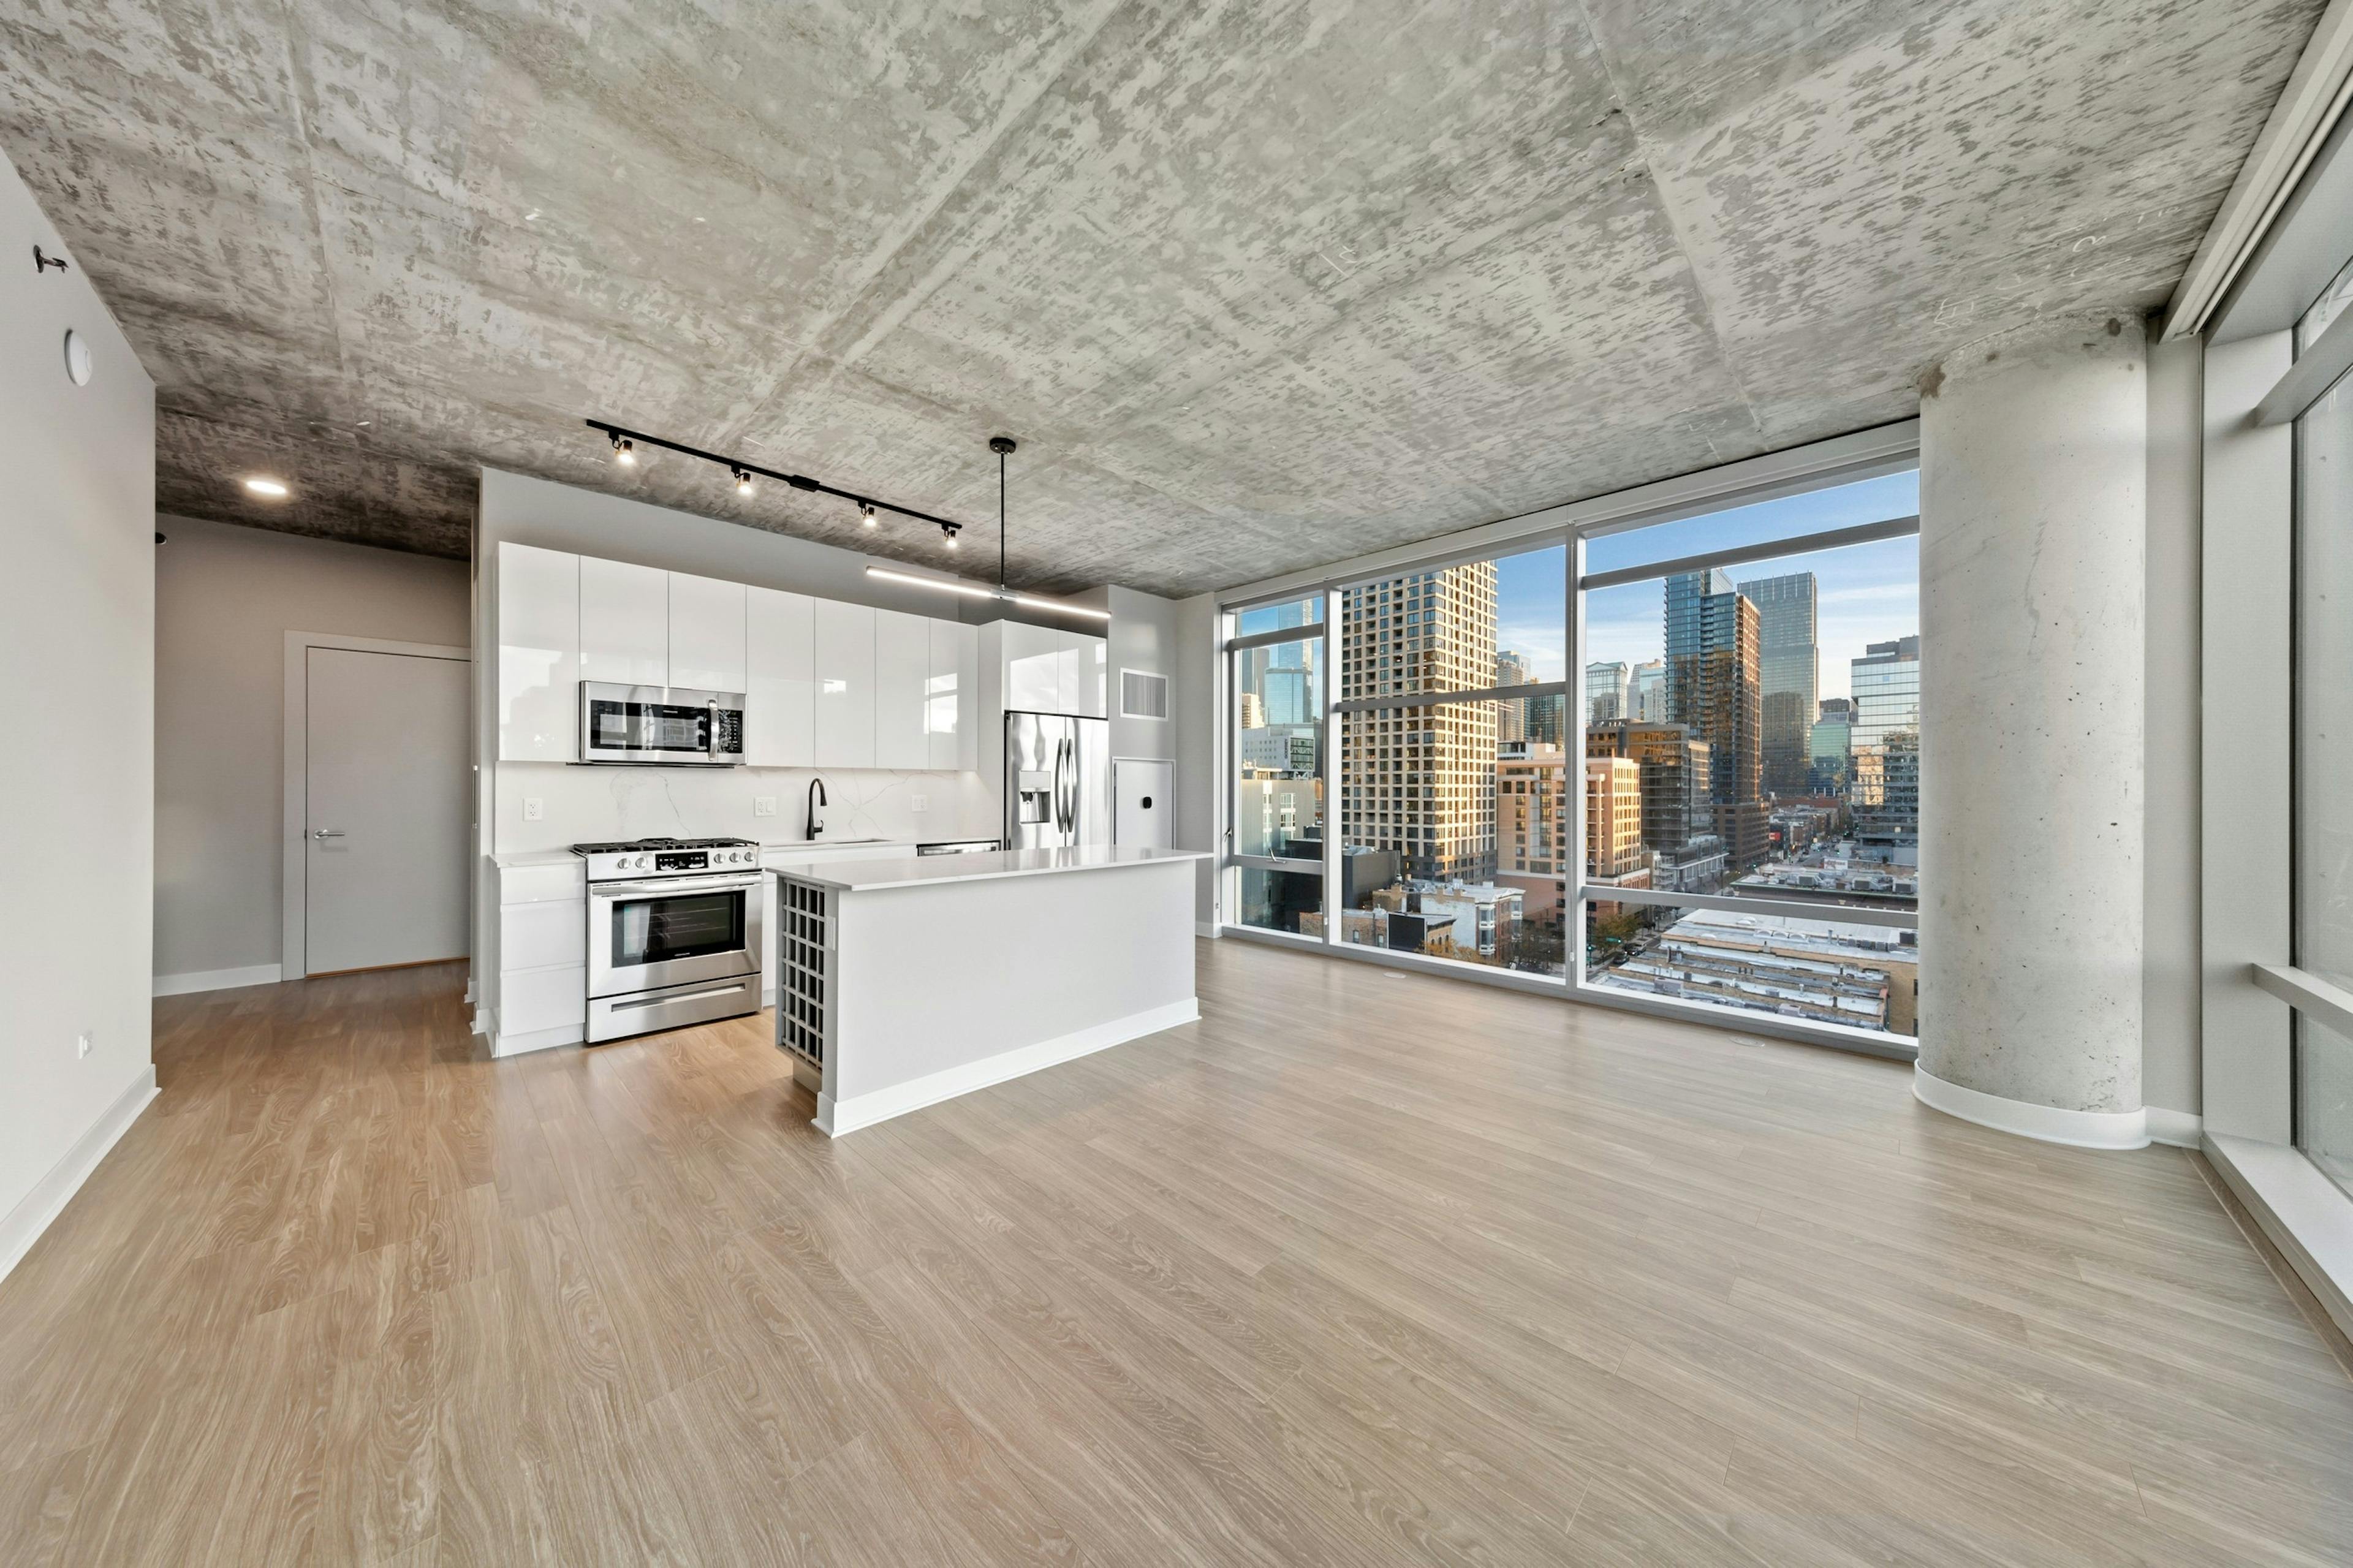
[588,874,765,996]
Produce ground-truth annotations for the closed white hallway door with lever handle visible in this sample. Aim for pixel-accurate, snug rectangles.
[301,648,471,975]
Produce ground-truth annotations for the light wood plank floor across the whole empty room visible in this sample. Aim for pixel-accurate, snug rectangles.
[0,942,2353,1568]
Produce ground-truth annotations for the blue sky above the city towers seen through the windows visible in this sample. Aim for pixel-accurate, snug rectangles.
[1496,473,1920,697]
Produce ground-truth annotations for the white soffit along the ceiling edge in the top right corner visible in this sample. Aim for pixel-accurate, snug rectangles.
[2160,0,2353,339]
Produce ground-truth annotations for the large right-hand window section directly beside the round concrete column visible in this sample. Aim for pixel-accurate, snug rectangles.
[1579,473,1934,1038]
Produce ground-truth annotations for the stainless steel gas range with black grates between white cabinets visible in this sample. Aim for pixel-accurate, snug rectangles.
[572,838,765,1045]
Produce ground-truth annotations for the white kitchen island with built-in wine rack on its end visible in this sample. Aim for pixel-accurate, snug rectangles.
[772,847,1202,1137]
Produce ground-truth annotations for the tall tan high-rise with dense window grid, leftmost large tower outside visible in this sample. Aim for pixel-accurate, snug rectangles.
[1339,560,1501,883]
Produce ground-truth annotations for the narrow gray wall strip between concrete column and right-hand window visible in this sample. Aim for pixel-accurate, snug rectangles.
[2141,336,2205,1113]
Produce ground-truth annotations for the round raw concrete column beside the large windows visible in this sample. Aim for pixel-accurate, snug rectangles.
[1913,313,2148,1149]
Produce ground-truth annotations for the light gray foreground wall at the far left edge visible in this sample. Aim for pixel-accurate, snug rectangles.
[0,160,155,1271]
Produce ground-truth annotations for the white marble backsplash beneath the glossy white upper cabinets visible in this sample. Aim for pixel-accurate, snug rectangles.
[492,763,998,855]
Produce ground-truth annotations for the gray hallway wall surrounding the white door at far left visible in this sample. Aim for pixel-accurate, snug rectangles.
[155,515,473,975]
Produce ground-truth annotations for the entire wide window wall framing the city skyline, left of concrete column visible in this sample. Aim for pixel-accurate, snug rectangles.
[1226,440,1934,1050]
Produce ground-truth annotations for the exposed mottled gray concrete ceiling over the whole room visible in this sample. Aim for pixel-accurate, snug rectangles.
[0,0,2322,593]
